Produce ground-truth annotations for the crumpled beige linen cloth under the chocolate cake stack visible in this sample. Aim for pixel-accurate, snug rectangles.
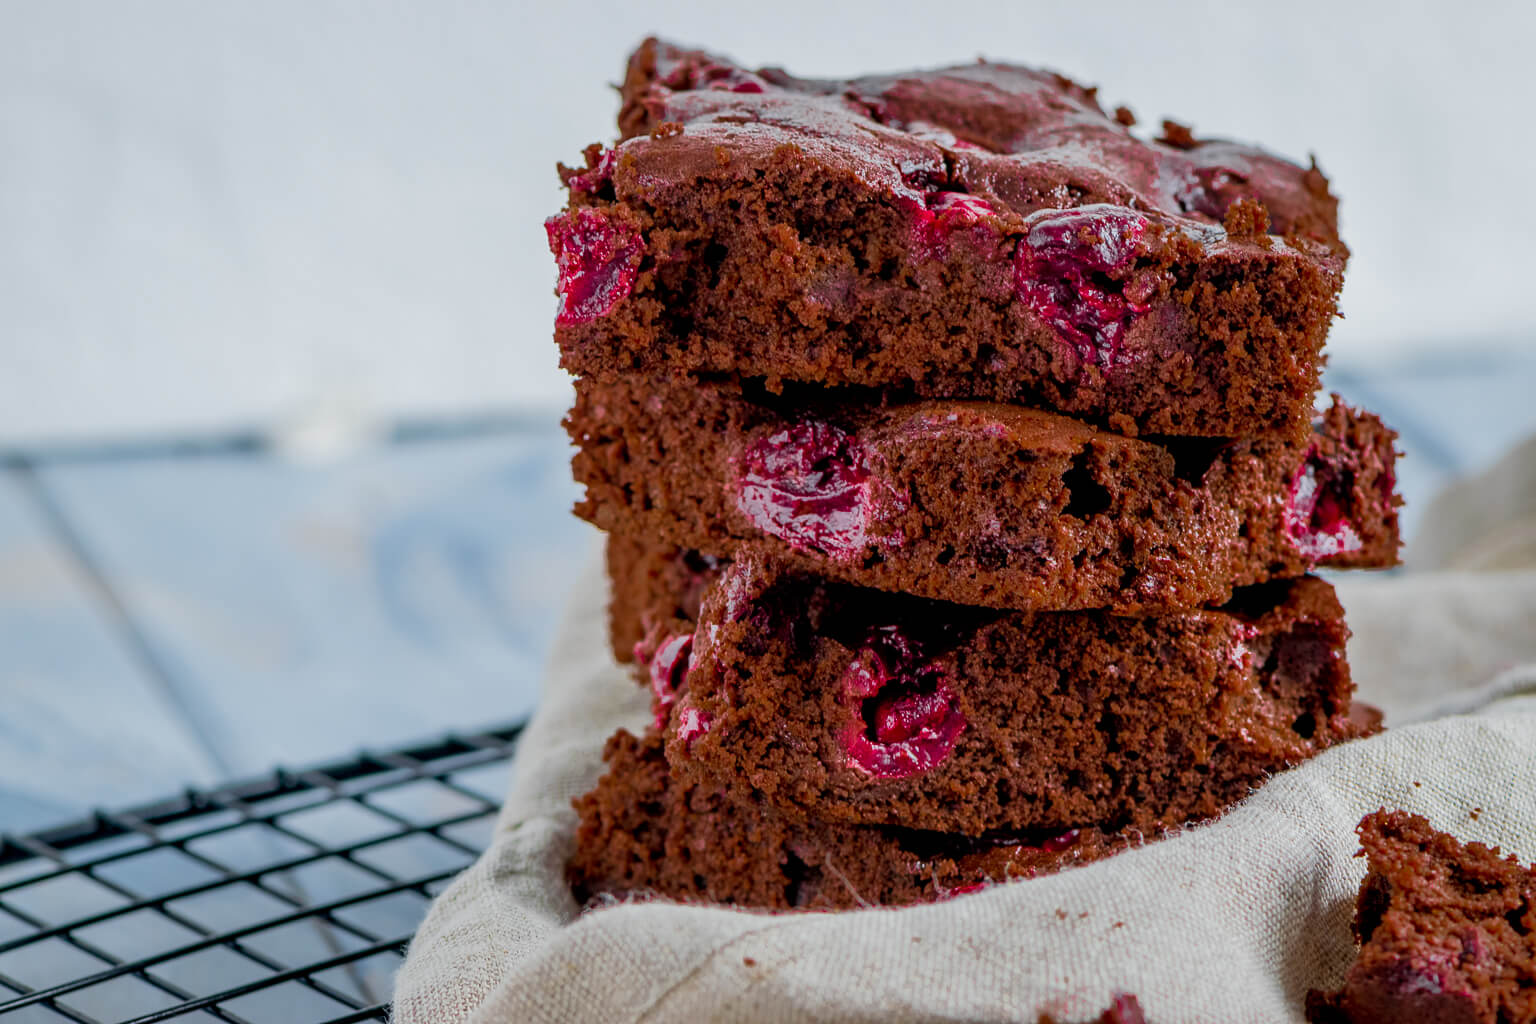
[395,444,1536,1024]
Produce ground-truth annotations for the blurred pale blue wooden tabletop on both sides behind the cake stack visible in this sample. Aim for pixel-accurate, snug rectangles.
[0,352,1536,831]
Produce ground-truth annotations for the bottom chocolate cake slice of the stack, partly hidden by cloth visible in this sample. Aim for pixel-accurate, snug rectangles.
[567,731,1155,910]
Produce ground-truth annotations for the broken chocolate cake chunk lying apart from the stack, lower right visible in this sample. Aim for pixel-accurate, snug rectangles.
[1307,811,1536,1024]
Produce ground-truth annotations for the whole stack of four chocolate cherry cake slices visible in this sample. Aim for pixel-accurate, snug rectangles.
[547,40,1398,909]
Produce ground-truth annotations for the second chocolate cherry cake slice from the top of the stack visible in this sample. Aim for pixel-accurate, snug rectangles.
[565,378,1399,614]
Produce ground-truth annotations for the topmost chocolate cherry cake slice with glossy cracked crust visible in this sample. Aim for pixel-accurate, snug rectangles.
[545,40,1347,438]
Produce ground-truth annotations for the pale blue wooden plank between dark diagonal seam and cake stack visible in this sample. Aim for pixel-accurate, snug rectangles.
[43,424,593,774]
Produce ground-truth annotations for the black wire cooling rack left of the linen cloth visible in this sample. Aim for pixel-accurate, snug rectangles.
[0,726,521,1024]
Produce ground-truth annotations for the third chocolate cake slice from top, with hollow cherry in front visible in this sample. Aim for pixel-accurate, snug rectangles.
[623,557,1378,835]
